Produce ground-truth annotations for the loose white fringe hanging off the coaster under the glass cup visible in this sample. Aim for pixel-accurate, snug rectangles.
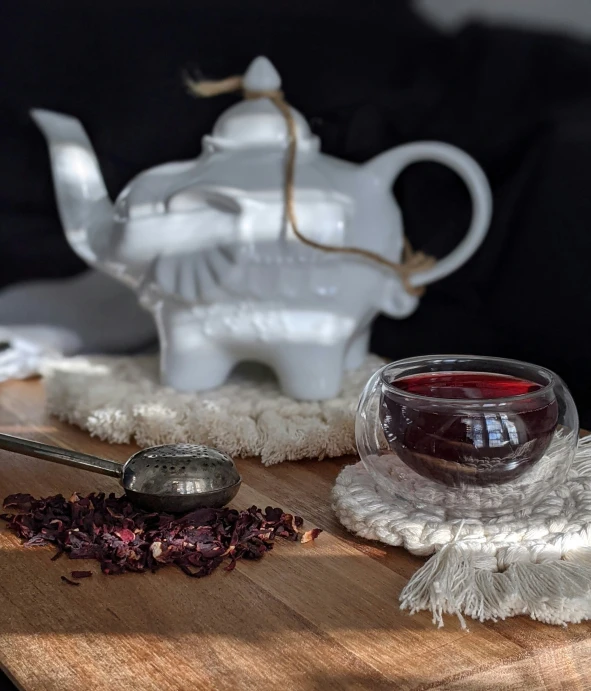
[400,541,591,630]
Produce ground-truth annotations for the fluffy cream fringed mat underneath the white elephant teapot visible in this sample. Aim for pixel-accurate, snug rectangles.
[43,356,383,465]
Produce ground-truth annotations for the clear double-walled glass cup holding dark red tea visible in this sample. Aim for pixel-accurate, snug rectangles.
[356,355,578,517]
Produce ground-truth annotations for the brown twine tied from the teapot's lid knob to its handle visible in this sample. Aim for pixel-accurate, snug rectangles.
[186,76,436,296]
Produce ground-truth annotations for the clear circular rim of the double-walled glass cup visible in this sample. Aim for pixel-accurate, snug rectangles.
[380,353,558,407]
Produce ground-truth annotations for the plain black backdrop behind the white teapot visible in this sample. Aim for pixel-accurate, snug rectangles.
[0,0,591,427]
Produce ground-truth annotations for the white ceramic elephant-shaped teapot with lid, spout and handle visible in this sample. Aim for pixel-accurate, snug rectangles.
[32,58,491,400]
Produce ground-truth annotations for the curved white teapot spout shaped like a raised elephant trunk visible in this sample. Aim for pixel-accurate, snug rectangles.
[31,109,113,270]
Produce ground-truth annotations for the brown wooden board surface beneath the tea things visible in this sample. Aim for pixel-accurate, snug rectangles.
[0,381,591,691]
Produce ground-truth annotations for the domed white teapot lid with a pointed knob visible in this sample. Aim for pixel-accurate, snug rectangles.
[204,57,319,151]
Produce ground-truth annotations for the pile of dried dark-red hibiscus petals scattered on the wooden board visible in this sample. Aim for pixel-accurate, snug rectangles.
[0,493,320,585]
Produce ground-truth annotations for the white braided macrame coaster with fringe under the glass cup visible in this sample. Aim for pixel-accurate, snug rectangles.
[333,437,591,628]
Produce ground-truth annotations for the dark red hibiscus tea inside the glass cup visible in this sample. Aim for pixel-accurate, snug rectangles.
[380,371,558,487]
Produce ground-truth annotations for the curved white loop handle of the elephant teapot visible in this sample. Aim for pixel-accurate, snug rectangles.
[366,142,492,288]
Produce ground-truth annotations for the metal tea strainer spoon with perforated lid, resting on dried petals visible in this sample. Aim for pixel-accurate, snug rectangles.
[0,434,242,513]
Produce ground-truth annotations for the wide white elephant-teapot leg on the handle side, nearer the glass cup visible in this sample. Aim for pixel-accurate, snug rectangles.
[269,343,345,401]
